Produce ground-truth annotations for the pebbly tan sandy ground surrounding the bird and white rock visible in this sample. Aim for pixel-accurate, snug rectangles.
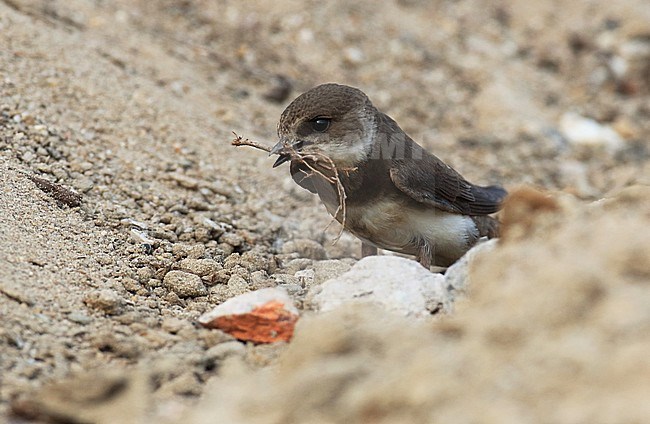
[0,0,650,423]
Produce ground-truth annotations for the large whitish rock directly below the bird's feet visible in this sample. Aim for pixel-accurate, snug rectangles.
[308,256,451,317]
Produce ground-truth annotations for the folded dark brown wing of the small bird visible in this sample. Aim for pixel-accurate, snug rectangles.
[390,132,507,215]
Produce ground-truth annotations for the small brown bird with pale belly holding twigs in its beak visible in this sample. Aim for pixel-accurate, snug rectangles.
[269,83,507,269]
